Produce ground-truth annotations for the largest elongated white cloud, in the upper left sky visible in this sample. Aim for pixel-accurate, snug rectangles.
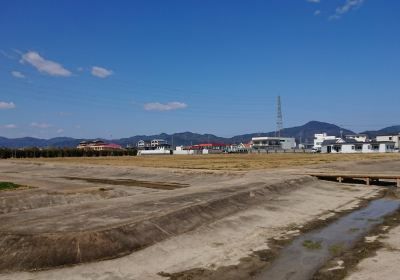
[20,51,72,77]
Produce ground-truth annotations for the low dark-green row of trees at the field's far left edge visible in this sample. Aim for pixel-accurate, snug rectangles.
[0,148,137,159]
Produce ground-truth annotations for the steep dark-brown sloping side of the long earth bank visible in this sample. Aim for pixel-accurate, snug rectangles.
[0,176,315,271]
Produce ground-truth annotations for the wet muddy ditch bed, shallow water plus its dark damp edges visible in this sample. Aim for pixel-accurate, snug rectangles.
[159,184,400,280]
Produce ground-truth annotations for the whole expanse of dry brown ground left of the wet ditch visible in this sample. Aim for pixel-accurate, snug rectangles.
[0,154,400,279]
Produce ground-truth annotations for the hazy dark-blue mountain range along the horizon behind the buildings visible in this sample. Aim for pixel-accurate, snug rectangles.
[0,121,400,148]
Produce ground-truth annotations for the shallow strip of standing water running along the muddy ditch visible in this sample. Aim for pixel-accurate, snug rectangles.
[255,198,400,280]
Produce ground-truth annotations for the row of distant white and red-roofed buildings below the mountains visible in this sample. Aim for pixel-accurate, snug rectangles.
[77,133,400,155]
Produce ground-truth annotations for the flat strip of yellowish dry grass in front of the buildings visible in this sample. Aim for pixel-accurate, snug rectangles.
[16,153,400,170]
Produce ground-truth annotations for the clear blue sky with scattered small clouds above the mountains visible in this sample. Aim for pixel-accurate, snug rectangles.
[0,0,400,138]
